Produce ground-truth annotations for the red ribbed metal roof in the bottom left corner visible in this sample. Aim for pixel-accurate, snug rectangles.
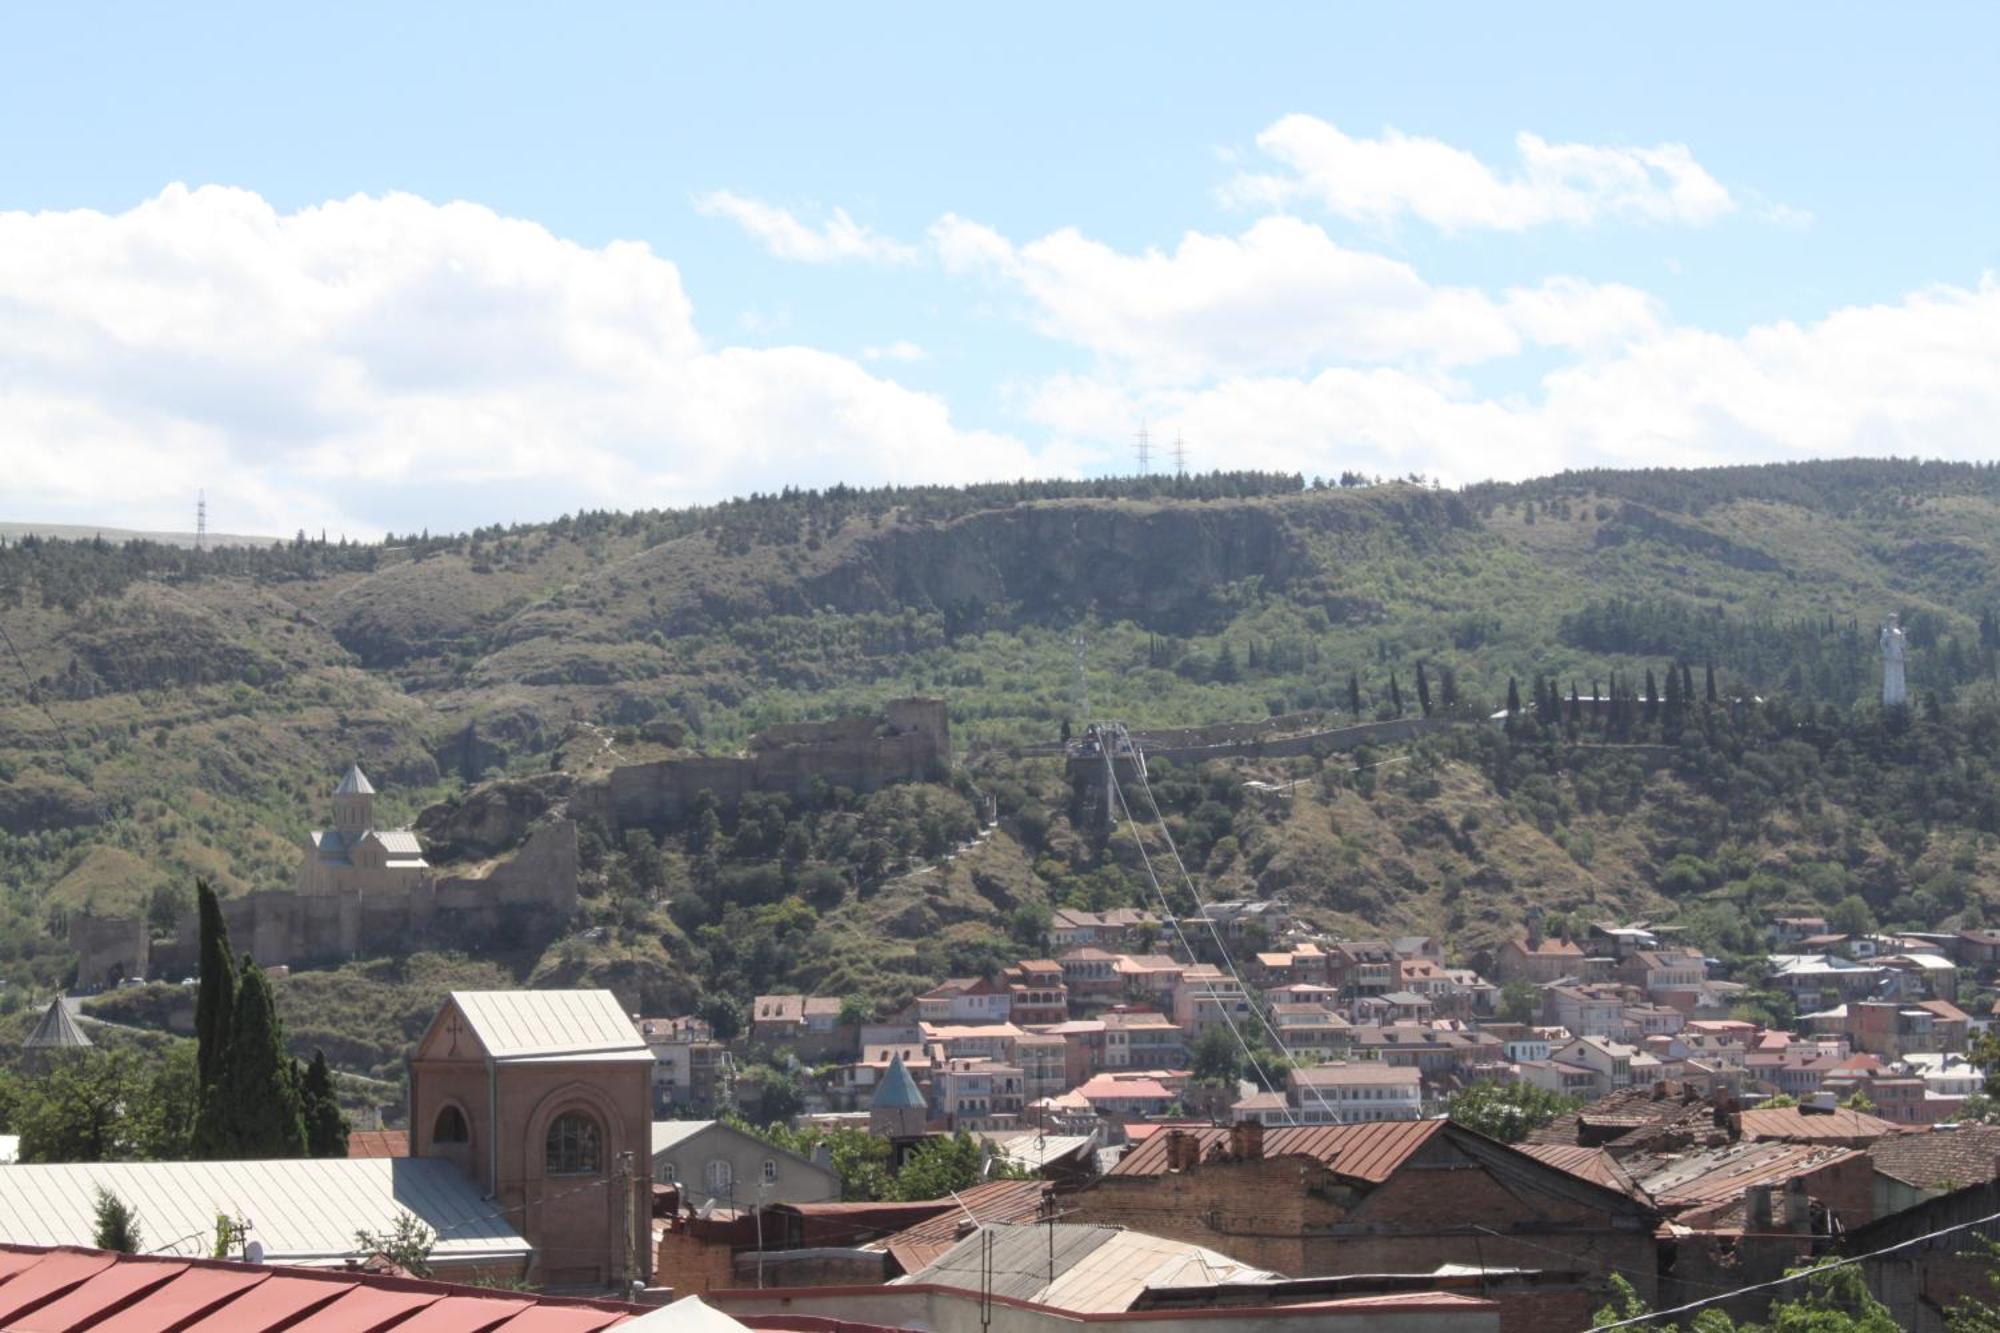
[0,1247,664,1333]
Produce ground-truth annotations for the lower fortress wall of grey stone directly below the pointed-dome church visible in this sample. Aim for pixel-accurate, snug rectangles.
[86,819,576,987]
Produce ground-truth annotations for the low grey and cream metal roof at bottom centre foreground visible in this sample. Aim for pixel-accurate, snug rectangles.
[896,1223,1276,1313]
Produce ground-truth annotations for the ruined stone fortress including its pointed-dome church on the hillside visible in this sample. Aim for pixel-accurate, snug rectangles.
[68,699,952,989]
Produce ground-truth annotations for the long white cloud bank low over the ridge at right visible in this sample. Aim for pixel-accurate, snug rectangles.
[1024,274,2000,482]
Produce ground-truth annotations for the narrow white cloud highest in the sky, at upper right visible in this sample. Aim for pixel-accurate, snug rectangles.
[1224,114,1736,230]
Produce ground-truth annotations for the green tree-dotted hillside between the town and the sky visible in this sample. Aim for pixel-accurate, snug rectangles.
[0,460,2000,1069]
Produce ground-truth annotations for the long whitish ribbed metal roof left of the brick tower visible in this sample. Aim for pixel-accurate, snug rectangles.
[0,1157,530,1263]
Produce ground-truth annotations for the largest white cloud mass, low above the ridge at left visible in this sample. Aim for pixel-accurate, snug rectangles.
[0,186,1074,534]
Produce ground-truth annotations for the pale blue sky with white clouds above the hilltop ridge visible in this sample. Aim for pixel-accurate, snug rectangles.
[0,2,2000,536]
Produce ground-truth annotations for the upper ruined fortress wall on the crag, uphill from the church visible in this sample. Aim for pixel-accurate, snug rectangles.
[604,699,952,831]
